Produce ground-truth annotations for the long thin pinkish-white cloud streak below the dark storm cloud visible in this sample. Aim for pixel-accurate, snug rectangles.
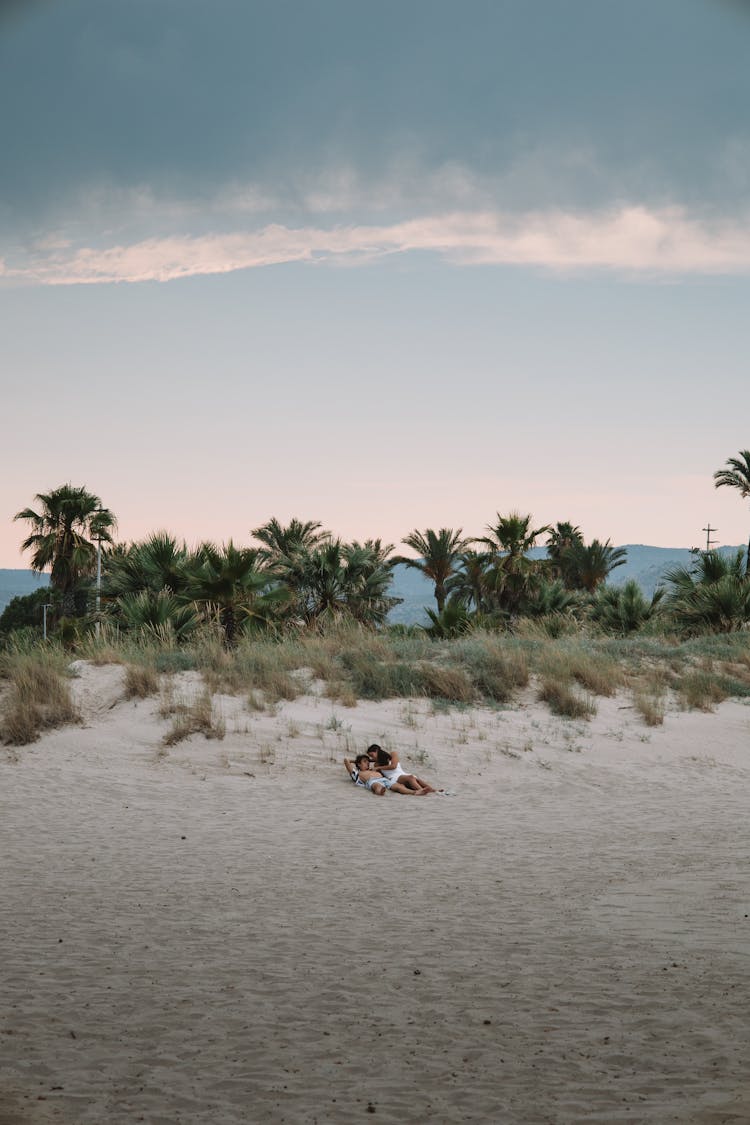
[0,206,750,286]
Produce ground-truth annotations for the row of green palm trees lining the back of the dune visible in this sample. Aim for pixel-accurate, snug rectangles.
[0,450,750,647]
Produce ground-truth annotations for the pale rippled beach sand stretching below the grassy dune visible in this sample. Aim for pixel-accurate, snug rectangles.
[0,664,750,1125]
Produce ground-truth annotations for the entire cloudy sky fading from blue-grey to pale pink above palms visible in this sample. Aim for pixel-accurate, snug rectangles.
[0,0,750,567]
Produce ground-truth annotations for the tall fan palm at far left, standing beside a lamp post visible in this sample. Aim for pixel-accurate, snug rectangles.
[13,484,117,617]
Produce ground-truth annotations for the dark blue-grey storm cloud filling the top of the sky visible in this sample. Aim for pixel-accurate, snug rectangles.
[0,0,750,226]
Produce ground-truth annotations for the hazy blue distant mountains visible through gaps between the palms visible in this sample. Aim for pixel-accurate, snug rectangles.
[0,543,744,624]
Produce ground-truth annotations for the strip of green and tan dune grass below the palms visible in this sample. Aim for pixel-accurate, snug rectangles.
[0,623,750,740]
